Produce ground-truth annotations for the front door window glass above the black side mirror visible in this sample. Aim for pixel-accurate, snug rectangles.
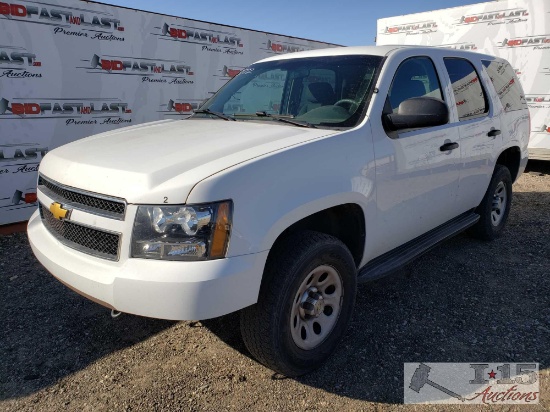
[388,57,443,113]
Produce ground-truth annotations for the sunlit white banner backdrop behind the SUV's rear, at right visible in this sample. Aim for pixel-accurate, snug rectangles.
[376,0,550,160]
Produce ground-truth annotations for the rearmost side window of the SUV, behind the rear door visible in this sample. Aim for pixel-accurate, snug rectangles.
[483,60,527,112]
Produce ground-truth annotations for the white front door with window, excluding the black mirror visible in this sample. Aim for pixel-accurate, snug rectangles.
[368,56,460,259]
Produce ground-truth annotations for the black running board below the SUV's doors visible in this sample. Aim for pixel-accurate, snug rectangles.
[357,212,479,283]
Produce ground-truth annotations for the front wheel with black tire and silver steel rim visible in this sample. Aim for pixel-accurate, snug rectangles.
[241,231,357,377]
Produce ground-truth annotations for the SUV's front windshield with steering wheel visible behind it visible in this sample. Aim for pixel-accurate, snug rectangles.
[198,56,382,127]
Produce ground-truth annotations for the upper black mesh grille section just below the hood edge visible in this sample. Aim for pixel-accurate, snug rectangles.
[38,175,126,220]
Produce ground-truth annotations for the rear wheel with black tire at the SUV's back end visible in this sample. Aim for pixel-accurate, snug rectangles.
[469,165,512,240]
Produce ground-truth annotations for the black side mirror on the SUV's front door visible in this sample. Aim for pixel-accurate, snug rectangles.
[383,97,449,131]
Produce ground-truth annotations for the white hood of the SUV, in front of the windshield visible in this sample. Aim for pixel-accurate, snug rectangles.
[40,119,335,204]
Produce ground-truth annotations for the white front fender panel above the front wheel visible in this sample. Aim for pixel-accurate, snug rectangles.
[188,126,376,256]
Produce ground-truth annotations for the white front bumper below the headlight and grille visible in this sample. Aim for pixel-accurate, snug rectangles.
[28,211,268,320]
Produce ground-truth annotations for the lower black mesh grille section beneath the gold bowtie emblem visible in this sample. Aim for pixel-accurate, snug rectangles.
[38,204,121,260]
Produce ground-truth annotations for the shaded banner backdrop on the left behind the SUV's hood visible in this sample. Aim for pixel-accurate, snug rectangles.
[0,0,335,224]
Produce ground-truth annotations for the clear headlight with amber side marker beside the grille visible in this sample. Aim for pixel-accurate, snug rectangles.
[131,201,233,260]
